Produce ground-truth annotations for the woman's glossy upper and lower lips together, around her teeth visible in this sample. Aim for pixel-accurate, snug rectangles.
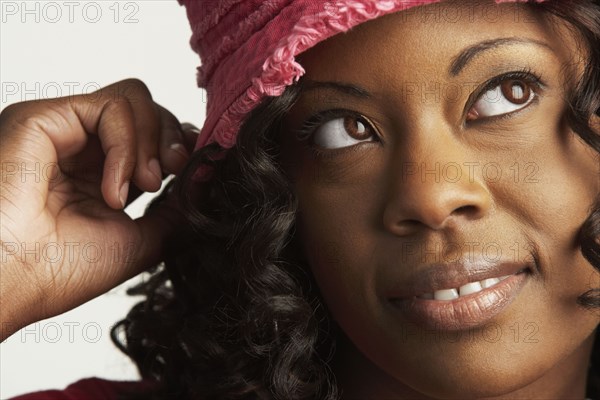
[389,263,533,331]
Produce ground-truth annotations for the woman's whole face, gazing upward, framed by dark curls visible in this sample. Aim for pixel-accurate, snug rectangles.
[283,1,600,398]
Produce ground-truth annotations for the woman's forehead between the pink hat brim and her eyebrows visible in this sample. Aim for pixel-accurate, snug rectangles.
[298,1,572,85]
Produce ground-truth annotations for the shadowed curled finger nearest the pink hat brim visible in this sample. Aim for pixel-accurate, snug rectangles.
[156,104,190,175]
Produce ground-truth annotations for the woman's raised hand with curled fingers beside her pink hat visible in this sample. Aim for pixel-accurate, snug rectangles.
[0,80,196,340]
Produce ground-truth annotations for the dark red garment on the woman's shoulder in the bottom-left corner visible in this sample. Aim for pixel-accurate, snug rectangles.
[9,378,152,400]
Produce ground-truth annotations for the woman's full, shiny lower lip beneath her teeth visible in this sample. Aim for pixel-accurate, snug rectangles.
[391,272,528,331]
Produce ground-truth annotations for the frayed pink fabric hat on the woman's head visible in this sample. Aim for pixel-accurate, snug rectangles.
[179,0,544,153]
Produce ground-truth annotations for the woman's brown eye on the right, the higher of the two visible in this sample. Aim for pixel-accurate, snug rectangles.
[467,79,537,121]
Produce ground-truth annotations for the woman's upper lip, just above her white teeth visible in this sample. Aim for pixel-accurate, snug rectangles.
[388,260,533,299]
